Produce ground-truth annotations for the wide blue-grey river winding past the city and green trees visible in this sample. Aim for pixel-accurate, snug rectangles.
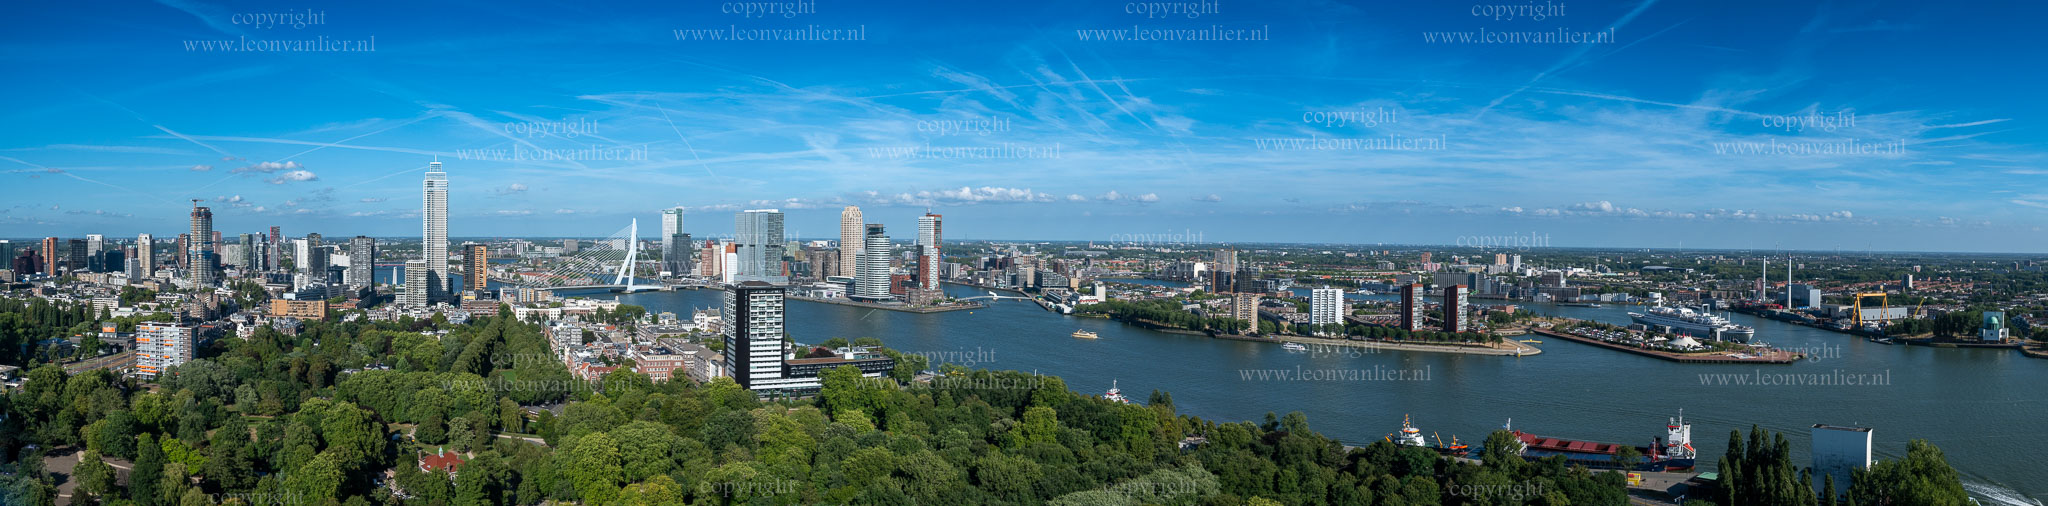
[563,283,2048,504]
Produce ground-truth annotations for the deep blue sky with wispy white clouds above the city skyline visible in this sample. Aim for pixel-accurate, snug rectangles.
[0,0,2048,252]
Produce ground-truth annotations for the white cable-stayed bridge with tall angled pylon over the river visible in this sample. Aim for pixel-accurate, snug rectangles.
[492,219,674,293]
